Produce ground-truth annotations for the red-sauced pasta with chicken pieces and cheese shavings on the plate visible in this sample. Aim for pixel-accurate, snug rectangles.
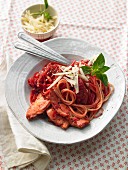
[26,57,114,129]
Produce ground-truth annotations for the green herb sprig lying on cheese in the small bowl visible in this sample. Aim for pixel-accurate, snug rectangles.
[32,0,52,21]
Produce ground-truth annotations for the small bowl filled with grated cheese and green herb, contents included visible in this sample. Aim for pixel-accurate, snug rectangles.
[21,4,59,41]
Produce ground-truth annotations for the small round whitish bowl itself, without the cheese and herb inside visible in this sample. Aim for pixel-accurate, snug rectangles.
[21,4,60,41]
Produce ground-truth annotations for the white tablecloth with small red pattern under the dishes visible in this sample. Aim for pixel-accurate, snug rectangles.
[0,0,128,170]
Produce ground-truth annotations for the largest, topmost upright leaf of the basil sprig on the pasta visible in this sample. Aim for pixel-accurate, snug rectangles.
[92,53,105,70]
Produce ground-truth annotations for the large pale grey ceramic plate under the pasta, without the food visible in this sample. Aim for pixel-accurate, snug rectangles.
[6,38,125,144]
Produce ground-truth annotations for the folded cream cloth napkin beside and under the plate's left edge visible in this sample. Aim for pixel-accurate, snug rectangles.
[0,52,51,170]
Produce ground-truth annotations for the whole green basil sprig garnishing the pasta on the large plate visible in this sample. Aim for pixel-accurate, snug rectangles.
[81,53,110,86]
